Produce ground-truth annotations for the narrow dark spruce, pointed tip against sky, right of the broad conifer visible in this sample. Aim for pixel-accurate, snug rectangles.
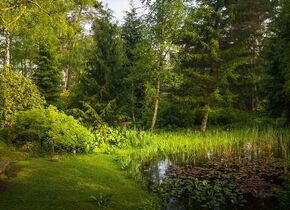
[122,1,146,125]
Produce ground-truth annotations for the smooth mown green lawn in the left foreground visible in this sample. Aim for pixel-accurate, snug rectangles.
[0,148,153,210]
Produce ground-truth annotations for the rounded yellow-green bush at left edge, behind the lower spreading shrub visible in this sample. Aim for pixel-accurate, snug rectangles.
[0,69,45,127]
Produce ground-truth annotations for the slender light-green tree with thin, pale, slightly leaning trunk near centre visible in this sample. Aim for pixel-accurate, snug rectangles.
[133,0,184,129]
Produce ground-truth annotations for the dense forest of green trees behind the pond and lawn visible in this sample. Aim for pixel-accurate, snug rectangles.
[0,0,290,131]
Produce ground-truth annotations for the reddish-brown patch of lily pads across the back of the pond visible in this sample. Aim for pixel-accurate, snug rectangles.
[166,157,289,198]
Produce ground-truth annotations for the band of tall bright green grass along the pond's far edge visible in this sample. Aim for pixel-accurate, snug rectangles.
[119,127,290,176]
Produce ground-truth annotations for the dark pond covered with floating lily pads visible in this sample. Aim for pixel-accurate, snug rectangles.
[142,144,289,210]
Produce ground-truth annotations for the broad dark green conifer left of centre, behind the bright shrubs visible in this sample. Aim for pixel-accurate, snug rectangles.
[73,12,125,123]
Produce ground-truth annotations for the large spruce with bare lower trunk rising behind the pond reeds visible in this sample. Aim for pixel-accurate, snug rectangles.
[178,0,247,132]
